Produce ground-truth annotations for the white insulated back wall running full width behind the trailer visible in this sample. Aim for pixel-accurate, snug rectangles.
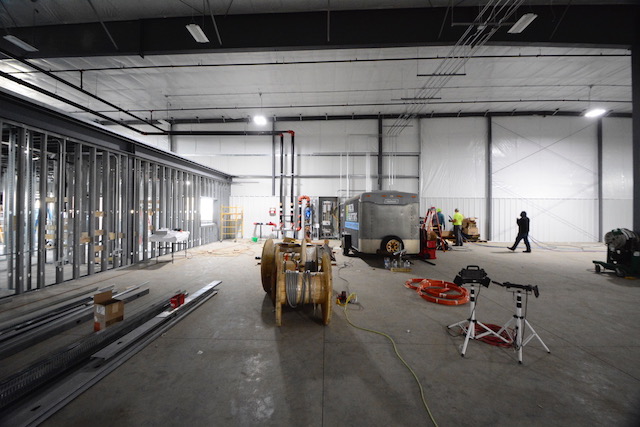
[175,116,633,242]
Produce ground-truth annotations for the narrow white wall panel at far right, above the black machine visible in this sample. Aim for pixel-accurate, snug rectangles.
[600,118,633,237]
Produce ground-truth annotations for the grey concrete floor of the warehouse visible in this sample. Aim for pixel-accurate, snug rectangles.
[0,241,640,426]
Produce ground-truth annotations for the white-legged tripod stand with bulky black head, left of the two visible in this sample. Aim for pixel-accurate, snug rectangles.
[447,265,509,357]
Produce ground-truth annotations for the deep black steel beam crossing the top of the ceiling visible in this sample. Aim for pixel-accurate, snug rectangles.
[0,5,637,58]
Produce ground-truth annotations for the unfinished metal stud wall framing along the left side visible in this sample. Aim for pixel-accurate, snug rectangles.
[0,95,230,297]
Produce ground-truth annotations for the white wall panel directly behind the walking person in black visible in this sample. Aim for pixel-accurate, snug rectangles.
[491,116,598,242]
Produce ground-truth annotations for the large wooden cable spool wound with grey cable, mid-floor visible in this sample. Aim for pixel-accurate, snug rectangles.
[260,239,333,326]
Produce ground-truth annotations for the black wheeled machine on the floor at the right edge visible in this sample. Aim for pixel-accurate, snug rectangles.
[593,228,640,277]
